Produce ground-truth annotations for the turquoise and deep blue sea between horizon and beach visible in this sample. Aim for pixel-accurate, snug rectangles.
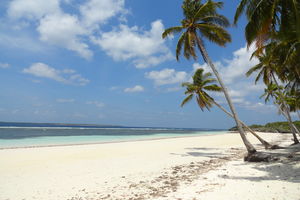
[0,123,226,149]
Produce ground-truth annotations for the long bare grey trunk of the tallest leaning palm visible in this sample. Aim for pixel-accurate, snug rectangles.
[196,36,256,154]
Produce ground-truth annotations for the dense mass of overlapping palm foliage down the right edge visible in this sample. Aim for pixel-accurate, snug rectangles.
[234,0,300,144]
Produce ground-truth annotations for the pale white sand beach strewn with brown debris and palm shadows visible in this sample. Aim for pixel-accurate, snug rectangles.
[0,133,300,200]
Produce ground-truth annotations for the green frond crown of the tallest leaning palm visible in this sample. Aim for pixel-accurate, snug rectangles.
[162,0,231,61]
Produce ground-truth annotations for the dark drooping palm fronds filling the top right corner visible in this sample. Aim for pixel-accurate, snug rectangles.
[234,0,300,88]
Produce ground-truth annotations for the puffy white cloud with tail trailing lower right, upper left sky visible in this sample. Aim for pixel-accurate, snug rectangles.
[37,14,93,59]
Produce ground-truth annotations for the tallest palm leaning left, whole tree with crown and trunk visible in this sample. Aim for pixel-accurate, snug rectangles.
[162,0,256,155]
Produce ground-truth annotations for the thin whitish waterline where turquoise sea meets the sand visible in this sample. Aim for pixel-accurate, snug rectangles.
[0,131,227,150]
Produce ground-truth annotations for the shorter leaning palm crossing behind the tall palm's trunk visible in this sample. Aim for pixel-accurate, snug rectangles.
[181,68,276,149]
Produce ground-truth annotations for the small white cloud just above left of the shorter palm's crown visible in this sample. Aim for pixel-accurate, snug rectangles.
[145,68,188,85]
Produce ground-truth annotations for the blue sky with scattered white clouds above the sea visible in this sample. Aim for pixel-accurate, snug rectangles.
[0,0,290,128]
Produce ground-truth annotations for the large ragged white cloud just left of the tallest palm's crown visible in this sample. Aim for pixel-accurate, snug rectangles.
[92,20,173,68]
